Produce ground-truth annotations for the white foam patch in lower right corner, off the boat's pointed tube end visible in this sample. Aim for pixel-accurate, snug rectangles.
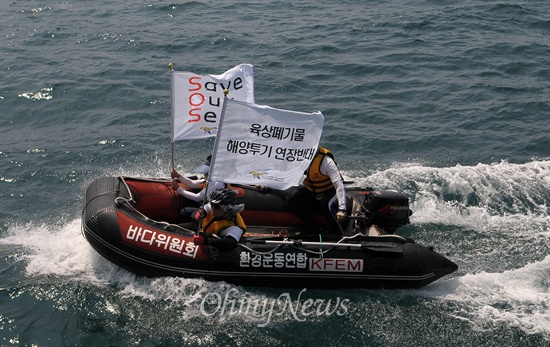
[417,255,550,341]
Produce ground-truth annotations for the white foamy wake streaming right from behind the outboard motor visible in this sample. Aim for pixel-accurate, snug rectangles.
[348,160,550,233]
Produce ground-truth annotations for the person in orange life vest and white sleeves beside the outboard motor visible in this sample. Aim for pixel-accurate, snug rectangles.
[286,147,348,233]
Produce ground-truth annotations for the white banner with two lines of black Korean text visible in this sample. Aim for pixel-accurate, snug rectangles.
[209,100,324,189]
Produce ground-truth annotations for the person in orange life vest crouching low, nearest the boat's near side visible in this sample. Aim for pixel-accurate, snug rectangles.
[194,188,246,251]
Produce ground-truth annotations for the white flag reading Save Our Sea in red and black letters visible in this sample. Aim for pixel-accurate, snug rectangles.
[171,64,254,142]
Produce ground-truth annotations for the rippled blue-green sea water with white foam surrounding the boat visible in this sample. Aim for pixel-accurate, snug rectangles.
[0,0,550,346]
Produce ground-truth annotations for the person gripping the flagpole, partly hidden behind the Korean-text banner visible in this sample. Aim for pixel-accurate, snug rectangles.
[171,155,225,218]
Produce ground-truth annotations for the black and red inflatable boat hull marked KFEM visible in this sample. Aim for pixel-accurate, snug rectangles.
[82,177,457,288]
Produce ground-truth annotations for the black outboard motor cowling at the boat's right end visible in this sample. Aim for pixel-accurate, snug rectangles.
[363,190,412,233]
